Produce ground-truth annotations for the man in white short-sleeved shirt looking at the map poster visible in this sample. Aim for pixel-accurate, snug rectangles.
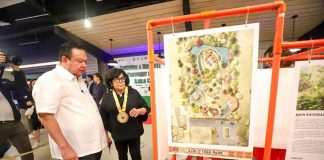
[32,42,107,160]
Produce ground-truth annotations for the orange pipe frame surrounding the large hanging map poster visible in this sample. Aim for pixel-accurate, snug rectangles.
[146,1,286,160]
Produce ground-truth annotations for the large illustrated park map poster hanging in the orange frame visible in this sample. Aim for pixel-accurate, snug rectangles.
[164,24,259,159]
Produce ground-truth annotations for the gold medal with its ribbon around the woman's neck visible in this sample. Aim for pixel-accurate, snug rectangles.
[113,87,129,123]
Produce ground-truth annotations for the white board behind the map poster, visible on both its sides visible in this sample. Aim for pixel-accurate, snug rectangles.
[155,68,312,160]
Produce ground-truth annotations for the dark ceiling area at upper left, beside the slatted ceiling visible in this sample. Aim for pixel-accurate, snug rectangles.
[0,0,170,64]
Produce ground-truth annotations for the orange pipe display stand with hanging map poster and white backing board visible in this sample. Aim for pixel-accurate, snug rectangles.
[146,1,324,160]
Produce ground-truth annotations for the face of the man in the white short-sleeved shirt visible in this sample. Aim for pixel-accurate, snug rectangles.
[62,48,88,77]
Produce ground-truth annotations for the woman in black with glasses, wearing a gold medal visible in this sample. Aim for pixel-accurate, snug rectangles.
[100,68,150,160]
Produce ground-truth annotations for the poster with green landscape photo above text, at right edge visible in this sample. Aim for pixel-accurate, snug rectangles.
[286,60,324,160]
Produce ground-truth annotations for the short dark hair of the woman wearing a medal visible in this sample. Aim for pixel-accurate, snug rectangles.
[105,68,129,89]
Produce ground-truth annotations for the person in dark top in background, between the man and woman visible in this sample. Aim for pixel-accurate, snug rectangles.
[92,73,107,107]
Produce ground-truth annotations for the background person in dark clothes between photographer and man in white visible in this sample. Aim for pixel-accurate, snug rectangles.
[25,79,42,148]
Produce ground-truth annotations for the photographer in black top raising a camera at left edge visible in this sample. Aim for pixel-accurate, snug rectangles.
[0,52,34,160]
